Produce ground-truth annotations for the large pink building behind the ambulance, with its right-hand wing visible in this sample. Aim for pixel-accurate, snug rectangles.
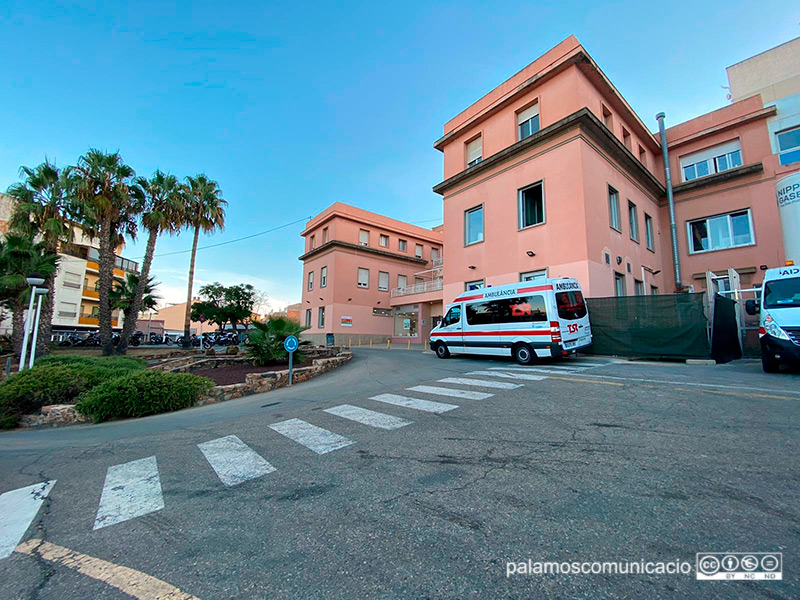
[434,36,800,302]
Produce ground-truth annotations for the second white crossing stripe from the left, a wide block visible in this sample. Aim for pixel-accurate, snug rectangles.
[94,456,164,529]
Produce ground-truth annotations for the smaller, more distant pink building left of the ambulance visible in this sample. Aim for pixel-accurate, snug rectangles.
[300,202,443,344]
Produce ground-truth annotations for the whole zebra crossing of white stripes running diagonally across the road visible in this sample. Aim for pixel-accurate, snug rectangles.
[0,358,602,559]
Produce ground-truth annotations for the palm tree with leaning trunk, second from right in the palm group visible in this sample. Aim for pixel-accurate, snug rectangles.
[117,170,188,354]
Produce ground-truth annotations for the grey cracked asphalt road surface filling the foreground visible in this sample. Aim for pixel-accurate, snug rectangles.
[0,349,800,599]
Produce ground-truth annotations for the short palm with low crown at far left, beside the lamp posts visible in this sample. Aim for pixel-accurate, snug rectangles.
[0,233,59,356]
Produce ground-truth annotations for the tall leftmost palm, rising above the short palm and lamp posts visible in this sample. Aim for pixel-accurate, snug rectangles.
[8,158,74,354]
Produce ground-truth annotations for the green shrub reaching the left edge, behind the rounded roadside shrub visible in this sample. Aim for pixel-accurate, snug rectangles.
[0,356,144,429]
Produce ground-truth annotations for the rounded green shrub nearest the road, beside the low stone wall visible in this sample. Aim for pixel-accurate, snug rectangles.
[76,371,214,423]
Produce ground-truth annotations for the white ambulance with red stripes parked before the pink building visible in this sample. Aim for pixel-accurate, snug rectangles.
[430,277,592,365]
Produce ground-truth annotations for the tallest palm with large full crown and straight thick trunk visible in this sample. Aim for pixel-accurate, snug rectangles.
[68,148,141,356]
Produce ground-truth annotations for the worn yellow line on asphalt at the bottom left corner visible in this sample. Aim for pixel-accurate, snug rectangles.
[15,540,199,600]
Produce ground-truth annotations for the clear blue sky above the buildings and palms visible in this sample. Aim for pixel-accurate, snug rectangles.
[0,0,800,307]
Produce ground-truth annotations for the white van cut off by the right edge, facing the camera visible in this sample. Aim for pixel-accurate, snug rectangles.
[745,265,800,373]
